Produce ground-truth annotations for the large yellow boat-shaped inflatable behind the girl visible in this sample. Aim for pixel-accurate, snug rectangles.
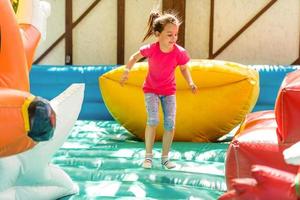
[99,60,259,142]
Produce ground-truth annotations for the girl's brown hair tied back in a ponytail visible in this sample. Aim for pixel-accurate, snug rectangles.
[142,11,181,42]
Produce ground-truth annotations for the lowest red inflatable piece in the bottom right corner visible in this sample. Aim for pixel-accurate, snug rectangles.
[219,165,297,200]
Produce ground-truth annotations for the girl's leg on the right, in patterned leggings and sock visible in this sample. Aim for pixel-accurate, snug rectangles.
[161,95,176,169]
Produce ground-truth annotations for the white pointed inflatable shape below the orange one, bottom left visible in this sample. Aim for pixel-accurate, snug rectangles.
[0,84,84,200]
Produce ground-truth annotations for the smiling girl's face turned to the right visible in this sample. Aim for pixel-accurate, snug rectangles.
[157,23,179,50]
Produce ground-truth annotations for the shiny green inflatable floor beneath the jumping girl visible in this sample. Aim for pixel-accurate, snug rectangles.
[52,121,228,200]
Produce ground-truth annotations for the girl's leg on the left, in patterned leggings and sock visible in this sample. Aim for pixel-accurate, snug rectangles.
[143,93,159,168]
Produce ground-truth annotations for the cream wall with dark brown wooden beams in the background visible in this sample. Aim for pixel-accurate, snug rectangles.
[36,0,300,65]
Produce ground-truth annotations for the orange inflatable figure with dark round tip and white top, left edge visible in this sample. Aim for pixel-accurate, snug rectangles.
[0,0,55,157]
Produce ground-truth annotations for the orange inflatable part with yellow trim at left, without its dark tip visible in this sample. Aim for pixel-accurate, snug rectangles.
[0,0,40,157]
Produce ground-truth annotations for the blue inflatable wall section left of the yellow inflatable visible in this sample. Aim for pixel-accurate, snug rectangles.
[30,65,117,120]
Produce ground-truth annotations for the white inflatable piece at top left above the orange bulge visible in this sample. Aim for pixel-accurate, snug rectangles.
[17,0,51,40]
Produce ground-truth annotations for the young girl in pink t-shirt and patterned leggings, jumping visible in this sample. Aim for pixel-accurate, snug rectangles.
[120,9,197,169]
